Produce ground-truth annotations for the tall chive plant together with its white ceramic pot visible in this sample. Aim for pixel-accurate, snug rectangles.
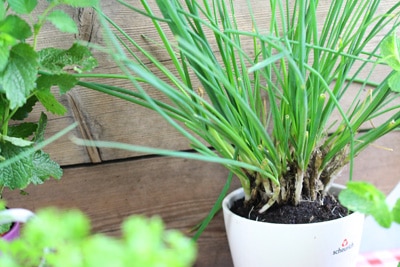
[76,0,400,266]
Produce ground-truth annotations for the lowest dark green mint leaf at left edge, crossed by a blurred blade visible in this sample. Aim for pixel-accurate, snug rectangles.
[0,142,34,190]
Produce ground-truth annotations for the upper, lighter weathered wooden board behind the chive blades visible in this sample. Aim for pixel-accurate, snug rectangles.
[27,0,400,165]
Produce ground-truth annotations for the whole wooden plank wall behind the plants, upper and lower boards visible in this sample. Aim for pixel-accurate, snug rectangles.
[4,0,400,266]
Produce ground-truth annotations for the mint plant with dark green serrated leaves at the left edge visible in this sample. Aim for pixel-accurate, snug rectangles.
[0,0,96,239]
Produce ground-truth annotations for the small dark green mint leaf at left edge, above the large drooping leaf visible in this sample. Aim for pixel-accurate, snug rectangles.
[0,15,32,40]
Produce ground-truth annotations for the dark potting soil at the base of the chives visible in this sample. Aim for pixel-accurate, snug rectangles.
[231,195,348,224]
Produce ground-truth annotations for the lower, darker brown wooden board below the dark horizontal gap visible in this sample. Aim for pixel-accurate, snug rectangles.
[4,133,400,267]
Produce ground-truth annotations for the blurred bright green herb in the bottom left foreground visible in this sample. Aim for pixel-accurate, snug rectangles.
[0,208,196,267]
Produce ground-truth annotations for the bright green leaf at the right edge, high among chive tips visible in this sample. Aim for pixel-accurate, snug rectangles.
[379,34,400,71]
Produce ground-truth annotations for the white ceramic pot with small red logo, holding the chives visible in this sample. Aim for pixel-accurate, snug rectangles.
[222,185,364,267]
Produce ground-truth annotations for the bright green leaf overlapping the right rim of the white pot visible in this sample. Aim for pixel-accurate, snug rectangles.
[339,181,392,228]
